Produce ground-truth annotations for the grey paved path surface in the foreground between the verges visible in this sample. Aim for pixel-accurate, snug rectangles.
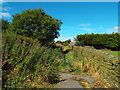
[55,73,95,88]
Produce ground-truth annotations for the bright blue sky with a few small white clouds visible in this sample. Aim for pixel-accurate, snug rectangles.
[0,0,118,41]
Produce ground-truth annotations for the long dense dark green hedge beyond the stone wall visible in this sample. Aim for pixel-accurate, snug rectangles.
[77,33,120,50]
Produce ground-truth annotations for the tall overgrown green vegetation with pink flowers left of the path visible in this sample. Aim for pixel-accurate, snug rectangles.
[2,32,63,88]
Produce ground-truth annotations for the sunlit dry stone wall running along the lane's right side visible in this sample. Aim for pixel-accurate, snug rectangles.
[74,47,120,88]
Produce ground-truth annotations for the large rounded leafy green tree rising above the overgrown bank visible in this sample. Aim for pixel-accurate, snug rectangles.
[11,9,62,45]
